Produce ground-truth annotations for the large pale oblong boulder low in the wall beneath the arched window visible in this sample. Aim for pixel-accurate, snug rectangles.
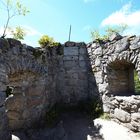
[114,108,131,123]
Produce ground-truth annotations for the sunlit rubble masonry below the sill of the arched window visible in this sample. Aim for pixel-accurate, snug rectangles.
[108,95,140,132]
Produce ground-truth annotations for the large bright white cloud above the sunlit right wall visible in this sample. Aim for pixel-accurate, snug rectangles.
[101,2,140,34]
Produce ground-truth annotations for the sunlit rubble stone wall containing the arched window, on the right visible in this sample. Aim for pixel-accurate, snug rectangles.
[87,34,140,131]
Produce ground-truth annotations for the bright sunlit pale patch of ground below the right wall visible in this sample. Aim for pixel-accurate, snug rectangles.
[94,119,140,140]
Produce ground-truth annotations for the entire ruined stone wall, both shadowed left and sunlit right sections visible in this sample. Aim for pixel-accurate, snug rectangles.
[0,34,140,139]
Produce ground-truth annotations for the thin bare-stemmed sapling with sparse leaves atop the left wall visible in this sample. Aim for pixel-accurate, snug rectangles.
[0,0,29,38]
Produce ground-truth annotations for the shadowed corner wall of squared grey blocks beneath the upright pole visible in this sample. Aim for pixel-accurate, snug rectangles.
[57,42,97,104]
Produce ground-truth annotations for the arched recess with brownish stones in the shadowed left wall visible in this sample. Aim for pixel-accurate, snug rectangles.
[5,71,45,130]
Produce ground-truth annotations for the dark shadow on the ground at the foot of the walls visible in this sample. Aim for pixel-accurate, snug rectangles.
[12,111,103,140]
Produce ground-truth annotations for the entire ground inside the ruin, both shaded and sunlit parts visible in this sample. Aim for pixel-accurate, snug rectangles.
[12,112,140,140]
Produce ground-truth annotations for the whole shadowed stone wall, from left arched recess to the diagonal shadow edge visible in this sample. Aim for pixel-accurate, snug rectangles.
[0,39,97,139]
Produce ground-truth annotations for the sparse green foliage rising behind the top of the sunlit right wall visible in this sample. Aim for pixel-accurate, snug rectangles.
[91,24,128,40]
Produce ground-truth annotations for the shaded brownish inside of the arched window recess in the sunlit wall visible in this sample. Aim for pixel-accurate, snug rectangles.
[107,60,135,96]
